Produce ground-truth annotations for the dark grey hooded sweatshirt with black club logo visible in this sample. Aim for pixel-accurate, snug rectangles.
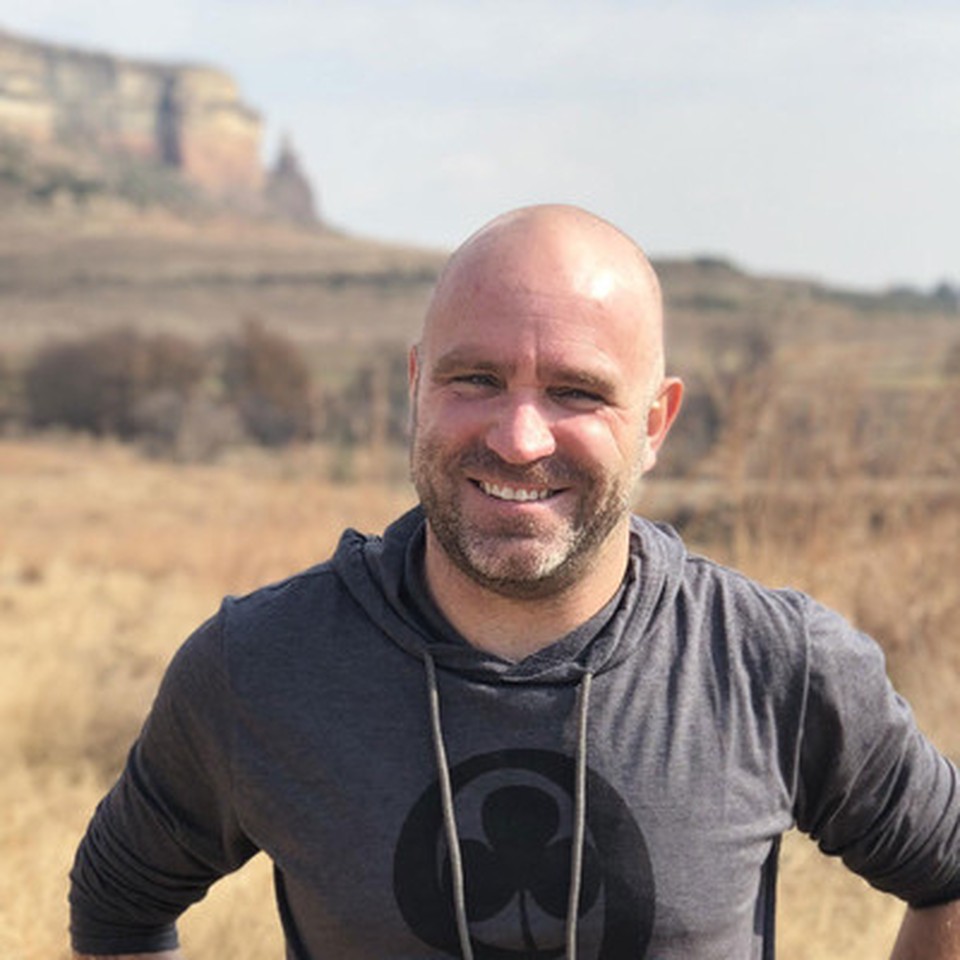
[71,509,960,960]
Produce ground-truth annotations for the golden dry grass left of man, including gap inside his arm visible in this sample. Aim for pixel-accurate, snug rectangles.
[0,441,411,960]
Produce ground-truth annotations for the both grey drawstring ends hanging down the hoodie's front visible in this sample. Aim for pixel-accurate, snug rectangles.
[423,652,593,960]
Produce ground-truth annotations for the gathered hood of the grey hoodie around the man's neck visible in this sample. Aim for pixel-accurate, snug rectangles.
[333,507,686,684]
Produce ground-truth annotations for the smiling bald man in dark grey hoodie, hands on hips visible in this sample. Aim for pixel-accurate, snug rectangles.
[71,206,960,960]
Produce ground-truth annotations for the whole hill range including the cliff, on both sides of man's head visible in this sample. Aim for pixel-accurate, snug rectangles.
[0,31,960,392]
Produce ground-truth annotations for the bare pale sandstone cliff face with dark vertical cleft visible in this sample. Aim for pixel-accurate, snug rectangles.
[0,25,313,219]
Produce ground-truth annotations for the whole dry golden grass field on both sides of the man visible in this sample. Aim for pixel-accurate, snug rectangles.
[0,439,960,960]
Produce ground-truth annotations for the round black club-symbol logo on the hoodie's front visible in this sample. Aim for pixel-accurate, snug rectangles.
[394,750,654,960]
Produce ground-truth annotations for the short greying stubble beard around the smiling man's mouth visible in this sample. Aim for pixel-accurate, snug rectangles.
[411,431,641,599]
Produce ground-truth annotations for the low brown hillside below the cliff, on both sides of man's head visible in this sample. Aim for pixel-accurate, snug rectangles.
[0,200,960,366]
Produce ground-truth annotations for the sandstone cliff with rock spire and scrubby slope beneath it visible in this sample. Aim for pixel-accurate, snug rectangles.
[0,29,317,223]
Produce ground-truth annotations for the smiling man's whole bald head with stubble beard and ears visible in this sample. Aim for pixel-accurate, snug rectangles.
[410,206,682,598]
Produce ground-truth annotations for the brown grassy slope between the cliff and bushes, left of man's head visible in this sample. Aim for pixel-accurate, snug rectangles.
[0,205,441,352]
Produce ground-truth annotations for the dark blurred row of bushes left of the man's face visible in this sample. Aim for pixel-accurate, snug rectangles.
[0,320,407,459]
